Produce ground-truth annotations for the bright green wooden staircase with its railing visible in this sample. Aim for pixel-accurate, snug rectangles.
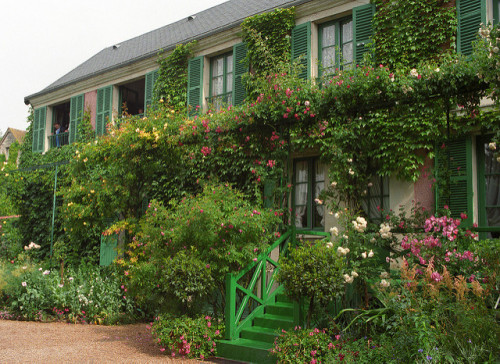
[217,227,329,364]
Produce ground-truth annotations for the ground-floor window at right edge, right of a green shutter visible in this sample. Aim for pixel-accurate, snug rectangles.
[476,137,500,239]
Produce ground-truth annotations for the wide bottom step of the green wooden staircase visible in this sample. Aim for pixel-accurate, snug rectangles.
[217,338,276,364]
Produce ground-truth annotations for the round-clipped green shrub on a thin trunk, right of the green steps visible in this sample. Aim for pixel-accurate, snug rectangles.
[277,242,344,326]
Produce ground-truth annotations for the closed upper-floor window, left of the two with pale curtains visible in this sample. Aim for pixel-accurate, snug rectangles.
[208,52,233,110]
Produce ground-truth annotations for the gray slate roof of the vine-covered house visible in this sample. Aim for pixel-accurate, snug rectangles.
[24,0,311,104]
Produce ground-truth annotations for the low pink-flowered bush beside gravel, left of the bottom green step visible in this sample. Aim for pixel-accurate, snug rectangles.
[151,315,224,359]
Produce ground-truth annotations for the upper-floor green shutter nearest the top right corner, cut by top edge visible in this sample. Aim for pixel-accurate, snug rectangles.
[457,0,486,55]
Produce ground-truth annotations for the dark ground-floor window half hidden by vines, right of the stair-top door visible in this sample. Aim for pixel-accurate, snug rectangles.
[362,176,389,224]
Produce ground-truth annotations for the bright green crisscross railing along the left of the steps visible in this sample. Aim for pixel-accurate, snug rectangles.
[225,226,330,340]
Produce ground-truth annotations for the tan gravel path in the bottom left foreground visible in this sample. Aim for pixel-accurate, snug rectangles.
[0,320,235,364]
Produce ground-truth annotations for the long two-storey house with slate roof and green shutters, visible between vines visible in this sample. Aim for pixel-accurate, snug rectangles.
[25,0,500,237]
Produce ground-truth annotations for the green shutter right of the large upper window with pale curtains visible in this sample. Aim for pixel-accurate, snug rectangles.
[352,4,375,64]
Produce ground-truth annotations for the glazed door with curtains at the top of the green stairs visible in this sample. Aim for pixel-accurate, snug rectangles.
[292,158,325,230]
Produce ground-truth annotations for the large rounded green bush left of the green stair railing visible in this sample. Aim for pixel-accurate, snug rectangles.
[123,185,279,314]
